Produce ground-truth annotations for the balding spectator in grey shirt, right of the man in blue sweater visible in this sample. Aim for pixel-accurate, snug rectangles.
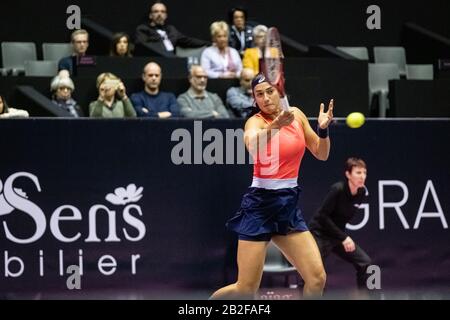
[178,65,230,118]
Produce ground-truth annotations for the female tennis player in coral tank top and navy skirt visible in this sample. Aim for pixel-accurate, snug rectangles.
[211,73,333,299]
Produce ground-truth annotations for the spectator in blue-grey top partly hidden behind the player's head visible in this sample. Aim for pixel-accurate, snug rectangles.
[227,68,255,118]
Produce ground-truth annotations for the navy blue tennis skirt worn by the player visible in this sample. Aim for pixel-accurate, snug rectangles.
[226,187,308,240]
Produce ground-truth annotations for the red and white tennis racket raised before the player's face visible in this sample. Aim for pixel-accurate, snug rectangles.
[261,27,289,111]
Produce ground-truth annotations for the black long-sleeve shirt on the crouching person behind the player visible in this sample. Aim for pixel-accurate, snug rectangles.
[309,181,366,241]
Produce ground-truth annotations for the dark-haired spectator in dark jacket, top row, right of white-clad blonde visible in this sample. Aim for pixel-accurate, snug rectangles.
[228,7,253,56]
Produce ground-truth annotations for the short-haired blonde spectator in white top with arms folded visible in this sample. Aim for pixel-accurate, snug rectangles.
[201,21,242,79]
